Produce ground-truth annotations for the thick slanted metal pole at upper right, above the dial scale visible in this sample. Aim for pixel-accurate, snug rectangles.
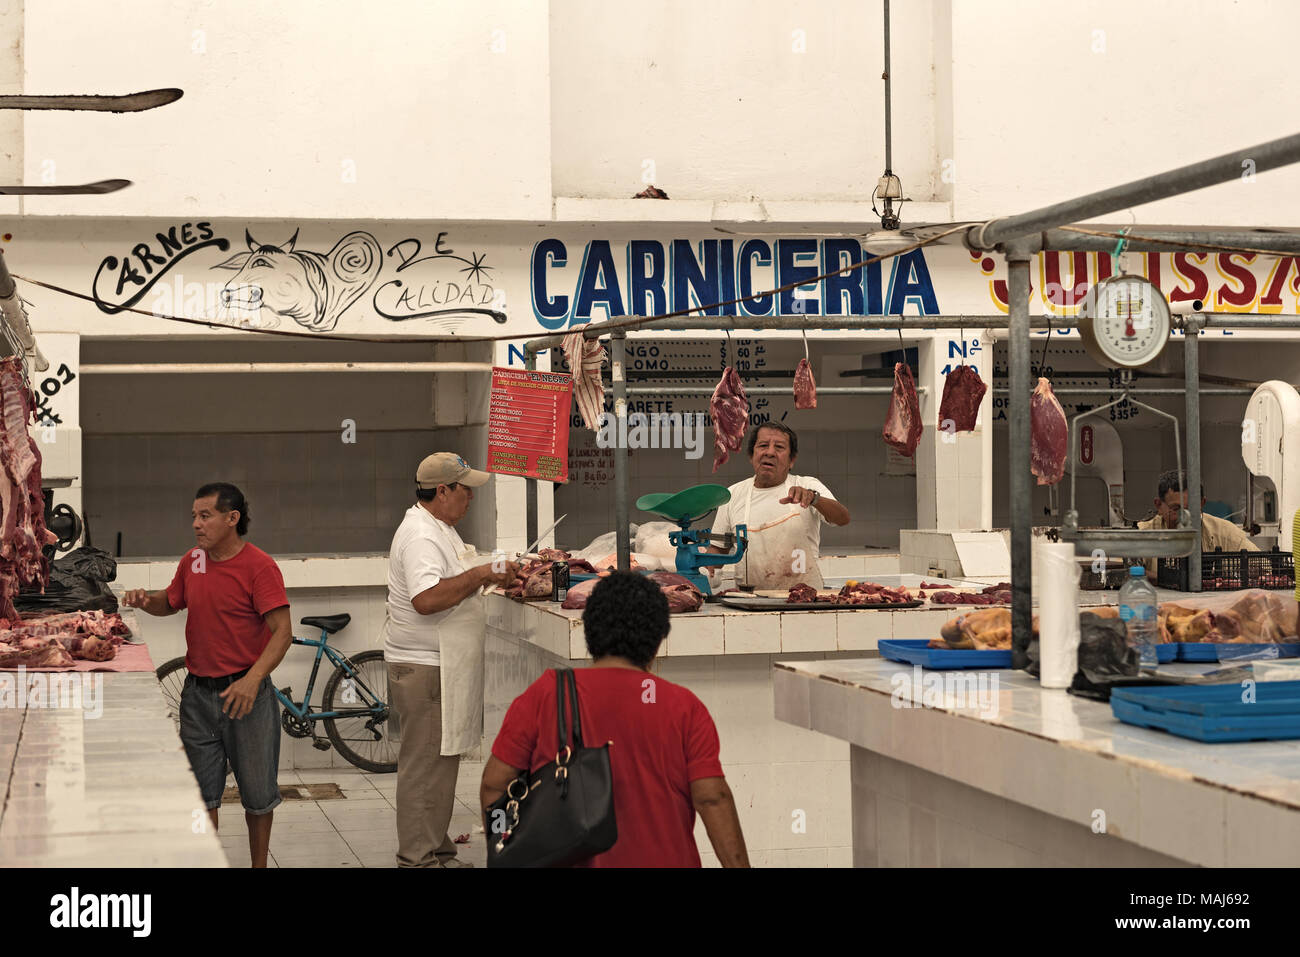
[966,134,1300,250]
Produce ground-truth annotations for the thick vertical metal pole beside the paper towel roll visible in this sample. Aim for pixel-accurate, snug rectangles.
[1006,243,1034,670]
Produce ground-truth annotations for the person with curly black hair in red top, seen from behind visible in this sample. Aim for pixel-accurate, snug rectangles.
[478,572,749,867]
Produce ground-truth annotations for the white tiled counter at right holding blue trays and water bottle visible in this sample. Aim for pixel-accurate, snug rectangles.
[774,658,1300,867]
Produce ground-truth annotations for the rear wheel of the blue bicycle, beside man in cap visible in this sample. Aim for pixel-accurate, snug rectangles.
[321,651,400,774]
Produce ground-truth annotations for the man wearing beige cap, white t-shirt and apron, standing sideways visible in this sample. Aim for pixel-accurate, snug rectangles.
[384,452,517,867]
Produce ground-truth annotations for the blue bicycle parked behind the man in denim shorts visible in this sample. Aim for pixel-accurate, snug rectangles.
[156,614,400,774]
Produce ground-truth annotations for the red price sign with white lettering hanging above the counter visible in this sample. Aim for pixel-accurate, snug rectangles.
[488,365,573,482]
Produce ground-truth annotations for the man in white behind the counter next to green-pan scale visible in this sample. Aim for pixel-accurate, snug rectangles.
[710,423,849,589]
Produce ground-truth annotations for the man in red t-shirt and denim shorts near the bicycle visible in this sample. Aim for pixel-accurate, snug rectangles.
[125,482,294,867]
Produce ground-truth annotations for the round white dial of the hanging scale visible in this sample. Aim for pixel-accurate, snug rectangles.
[1079,276,1173,369]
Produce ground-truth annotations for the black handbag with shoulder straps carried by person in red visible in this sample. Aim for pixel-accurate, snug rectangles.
[488,668,619,867]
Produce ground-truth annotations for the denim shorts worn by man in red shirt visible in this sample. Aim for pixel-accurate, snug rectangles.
[181,675,280,814]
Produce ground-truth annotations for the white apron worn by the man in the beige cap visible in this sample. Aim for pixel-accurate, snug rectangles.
[438,545,488,754]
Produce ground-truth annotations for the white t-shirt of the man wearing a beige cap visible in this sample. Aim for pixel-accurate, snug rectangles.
[384,503,465,666]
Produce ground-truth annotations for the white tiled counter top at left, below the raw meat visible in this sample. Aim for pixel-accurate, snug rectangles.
[0,672,229,867]
